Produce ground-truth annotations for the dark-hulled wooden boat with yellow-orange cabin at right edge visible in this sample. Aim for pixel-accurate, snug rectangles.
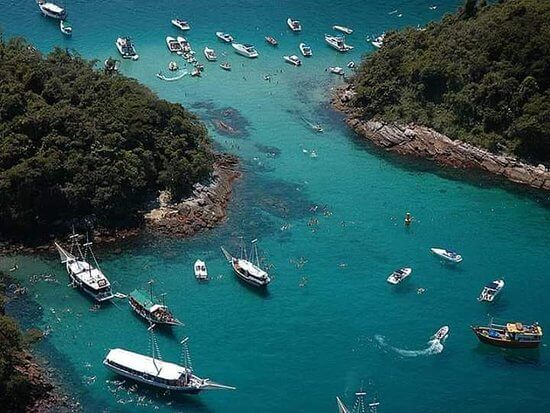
[471,321,543,348]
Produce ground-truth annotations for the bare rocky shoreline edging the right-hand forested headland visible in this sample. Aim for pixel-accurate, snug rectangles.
[332,85,550,191]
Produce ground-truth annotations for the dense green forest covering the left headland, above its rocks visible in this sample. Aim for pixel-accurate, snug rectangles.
[0,39,213,238]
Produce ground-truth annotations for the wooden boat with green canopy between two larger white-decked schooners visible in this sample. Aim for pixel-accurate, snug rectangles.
[128,280,182,326]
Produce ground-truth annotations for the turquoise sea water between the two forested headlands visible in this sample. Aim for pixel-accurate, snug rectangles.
[0,0,550,412]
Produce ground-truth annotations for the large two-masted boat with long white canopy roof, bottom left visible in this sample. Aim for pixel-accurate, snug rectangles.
[103,324,235,394]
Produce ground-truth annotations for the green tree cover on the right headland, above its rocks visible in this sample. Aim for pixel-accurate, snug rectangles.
[353,0,550,162]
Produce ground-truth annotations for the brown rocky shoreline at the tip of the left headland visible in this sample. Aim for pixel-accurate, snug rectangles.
[145,154,241,236]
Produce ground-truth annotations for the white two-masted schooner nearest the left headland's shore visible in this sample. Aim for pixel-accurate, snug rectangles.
[54,231,113,302]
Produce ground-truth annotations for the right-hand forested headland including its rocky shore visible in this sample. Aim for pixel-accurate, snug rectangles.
[334,0,550,190]
